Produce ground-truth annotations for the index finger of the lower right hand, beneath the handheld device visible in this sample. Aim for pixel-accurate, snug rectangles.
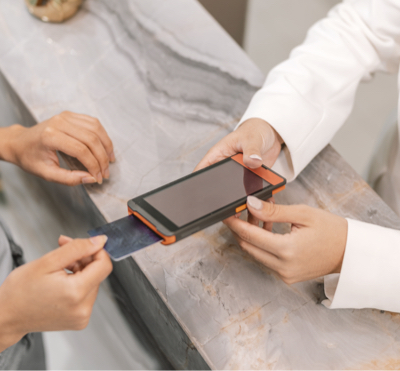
[225,218,287,258]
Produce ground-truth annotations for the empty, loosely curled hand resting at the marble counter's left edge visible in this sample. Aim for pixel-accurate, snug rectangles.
[0,112,115,186]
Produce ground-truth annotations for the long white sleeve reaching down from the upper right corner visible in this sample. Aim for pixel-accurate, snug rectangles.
[239,0,400,181]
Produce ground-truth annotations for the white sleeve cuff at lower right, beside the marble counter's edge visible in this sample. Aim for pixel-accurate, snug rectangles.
[322,219,400,312]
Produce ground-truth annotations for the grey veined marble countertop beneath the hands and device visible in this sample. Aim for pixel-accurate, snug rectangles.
[0,0,400,369]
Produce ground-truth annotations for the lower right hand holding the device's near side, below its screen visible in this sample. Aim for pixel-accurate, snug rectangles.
[225,196,347,284]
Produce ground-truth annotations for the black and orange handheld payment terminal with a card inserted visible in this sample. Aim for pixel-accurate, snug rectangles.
[128,153,286,245]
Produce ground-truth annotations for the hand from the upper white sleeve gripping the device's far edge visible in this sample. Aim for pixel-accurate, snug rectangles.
[195,118,283,171]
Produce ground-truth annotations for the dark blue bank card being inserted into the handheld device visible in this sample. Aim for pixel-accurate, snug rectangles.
[88,215,162,261]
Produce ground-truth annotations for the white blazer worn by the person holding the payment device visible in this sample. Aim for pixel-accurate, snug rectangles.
[239,0,400,312]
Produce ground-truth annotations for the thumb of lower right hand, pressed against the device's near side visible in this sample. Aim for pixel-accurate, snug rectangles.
[247,196,308,224]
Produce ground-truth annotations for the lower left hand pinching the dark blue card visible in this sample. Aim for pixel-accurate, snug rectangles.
[0,236,112,352]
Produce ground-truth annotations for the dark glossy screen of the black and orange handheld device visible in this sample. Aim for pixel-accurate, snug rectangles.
[144,159,270,227]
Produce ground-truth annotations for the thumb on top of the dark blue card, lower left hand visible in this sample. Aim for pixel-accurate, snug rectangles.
[42,235,107,273]
